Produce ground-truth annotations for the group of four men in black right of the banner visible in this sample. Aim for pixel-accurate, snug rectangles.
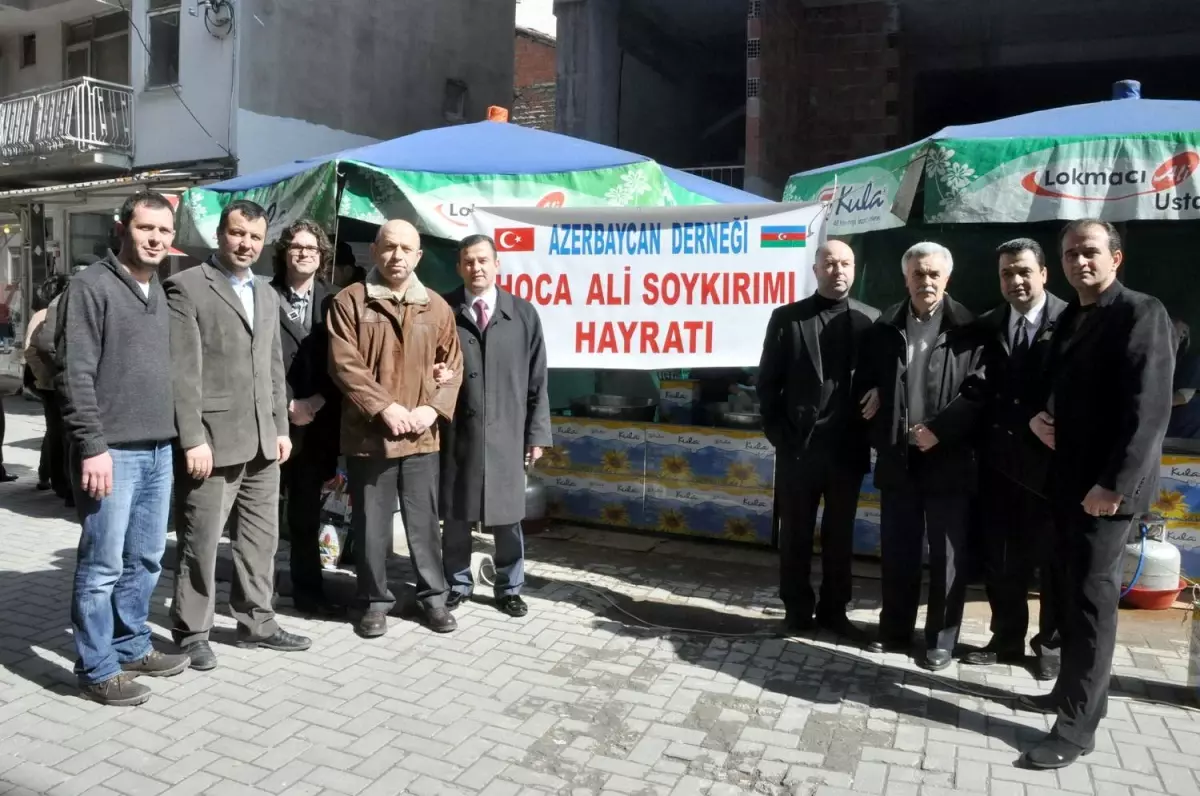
[758,220,1175,768]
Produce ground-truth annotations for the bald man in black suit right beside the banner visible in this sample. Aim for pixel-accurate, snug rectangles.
[757,240,880,640]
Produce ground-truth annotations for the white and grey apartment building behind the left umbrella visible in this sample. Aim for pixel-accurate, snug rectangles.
[0,0,516,386]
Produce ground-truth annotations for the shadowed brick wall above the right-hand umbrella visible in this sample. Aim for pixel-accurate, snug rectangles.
[746,0,900,188]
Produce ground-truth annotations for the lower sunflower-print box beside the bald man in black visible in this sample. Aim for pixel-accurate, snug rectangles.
[642,478,774,545]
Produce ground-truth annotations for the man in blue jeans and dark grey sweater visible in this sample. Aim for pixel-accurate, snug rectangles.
[55,193,188,706]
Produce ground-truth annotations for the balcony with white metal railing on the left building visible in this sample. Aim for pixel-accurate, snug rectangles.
[0,77,133,182]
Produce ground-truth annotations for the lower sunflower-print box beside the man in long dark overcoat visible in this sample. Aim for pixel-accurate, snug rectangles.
[530,465,646,528]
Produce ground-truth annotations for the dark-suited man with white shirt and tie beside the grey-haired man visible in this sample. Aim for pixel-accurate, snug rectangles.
[962,238,1067,680]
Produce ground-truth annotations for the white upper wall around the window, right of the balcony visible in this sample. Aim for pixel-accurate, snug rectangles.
[130,0,236,168]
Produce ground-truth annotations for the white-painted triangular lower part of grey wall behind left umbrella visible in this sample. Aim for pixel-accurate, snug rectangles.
[236,108,378,174]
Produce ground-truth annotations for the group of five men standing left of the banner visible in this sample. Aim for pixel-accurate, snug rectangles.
[55,193,550,705]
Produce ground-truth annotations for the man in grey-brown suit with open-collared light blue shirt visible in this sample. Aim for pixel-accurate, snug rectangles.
[166,201,312,671]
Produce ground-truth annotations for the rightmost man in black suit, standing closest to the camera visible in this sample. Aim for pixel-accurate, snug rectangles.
[1020,219,1175,768]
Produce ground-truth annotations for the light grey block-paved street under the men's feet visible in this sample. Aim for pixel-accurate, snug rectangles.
[0,399,1200,796]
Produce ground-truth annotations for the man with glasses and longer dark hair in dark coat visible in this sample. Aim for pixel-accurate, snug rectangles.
[271,219,343,616]
